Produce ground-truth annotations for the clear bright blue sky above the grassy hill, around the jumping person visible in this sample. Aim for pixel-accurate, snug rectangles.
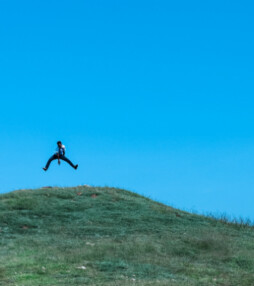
[0,0,254,220]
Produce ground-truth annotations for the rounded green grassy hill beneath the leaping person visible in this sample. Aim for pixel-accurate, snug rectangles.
[0,186,254,286]
